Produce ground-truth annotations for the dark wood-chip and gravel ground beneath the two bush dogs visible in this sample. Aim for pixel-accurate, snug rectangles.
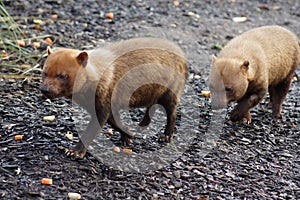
[0,0,300,199]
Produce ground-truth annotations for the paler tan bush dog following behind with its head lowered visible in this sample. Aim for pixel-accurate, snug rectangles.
[210,26,300,123]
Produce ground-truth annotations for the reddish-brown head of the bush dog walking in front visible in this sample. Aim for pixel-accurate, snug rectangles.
[40,47,88,98]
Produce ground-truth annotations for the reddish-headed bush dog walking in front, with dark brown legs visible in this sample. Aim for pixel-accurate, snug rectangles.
[40,38,188,158]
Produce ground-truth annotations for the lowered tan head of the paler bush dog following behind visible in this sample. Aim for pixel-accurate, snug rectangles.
[209,56,249,109]
